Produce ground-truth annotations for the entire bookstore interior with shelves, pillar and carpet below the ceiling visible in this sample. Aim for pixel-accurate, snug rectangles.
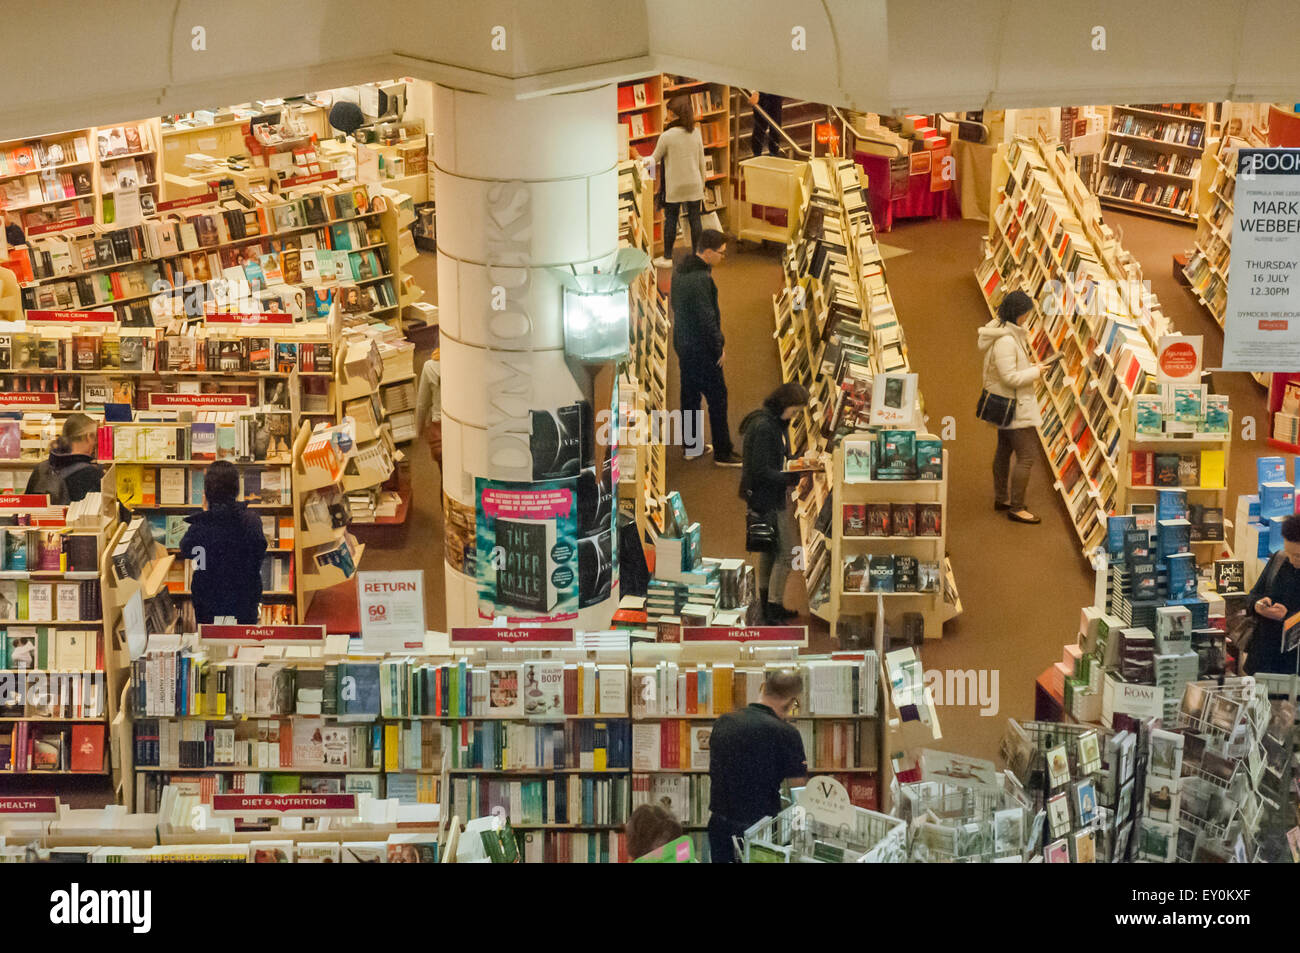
[0,44,1300,863]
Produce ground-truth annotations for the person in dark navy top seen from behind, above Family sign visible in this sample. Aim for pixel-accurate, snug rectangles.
[181,460,267,625]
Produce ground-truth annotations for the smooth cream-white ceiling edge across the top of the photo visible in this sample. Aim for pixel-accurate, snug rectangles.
[0,0,1300,138]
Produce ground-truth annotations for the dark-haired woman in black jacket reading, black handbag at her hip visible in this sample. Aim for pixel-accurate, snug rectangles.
[740,382,809,625]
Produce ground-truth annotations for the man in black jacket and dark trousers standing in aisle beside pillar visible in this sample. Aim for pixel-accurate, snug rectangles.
[670,229,740,467]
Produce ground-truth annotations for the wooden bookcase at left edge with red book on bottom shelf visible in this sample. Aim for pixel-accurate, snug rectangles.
[0,481,124,790]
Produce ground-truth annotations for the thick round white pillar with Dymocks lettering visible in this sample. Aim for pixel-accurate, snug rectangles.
[433,85,619,629]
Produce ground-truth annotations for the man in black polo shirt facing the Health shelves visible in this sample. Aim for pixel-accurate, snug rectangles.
[709,672,807,863]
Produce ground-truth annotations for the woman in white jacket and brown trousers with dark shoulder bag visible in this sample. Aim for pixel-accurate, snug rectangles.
[979,291,1045,523]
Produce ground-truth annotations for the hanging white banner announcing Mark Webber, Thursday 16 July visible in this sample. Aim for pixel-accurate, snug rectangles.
[1223,148,1300,371]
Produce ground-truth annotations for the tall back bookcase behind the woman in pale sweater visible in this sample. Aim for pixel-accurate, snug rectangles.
[618,74,733,251]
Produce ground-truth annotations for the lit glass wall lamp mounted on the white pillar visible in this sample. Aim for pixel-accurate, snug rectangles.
[555,248,650,364]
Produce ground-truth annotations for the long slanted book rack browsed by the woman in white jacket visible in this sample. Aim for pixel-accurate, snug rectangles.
[975,130,1169,554]
